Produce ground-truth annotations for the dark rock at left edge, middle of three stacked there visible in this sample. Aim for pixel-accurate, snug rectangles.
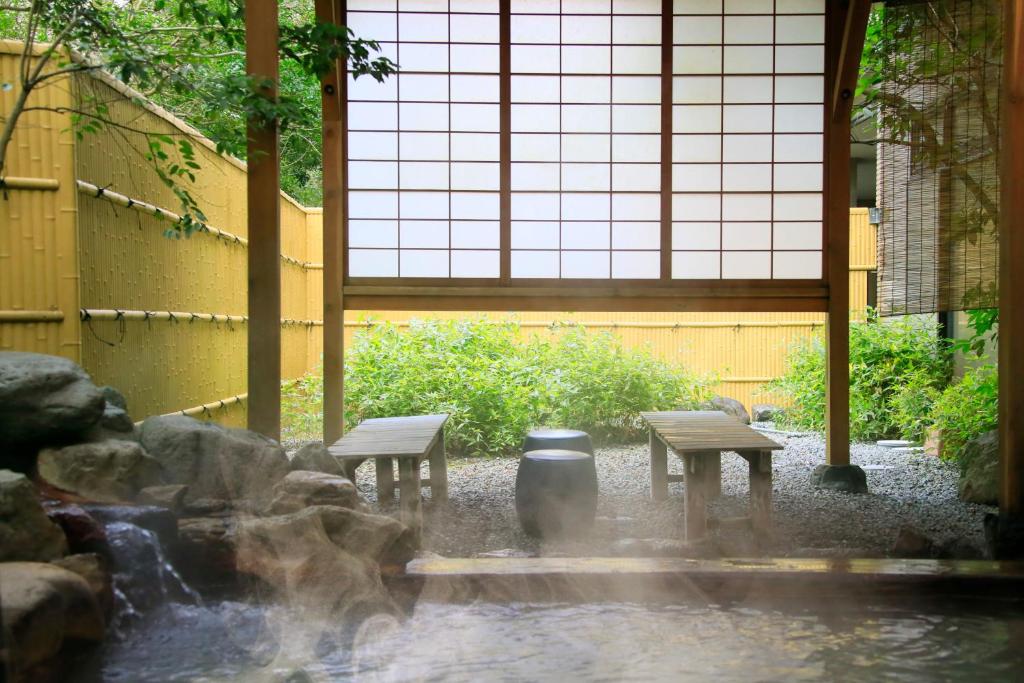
[0,470,68,562]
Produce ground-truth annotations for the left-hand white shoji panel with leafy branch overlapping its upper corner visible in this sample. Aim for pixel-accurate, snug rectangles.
[347,0,500,279]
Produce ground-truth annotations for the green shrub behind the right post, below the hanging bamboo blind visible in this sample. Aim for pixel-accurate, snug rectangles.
[768,315,949,440]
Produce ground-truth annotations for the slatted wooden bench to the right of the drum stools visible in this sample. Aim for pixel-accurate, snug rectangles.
[640,411,782,541]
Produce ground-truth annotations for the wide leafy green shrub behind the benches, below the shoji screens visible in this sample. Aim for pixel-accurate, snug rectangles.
[284,318,709,455]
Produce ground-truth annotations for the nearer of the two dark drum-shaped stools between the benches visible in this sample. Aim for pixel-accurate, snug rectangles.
[515,449,597,538]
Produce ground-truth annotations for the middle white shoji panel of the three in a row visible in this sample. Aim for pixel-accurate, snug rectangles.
[510,0,662,280]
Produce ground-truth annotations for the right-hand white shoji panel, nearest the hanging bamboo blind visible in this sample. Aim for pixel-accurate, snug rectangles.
[672,0,825,280]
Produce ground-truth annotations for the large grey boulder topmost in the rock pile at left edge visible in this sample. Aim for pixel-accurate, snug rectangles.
[0,351,105,450]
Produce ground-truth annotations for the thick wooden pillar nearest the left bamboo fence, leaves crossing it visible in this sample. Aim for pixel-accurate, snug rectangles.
[246,0,281,440]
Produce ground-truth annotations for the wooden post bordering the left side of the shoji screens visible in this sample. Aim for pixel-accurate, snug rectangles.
[316,0,346,444]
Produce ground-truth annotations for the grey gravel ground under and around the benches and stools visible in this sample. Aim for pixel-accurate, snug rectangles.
[348,433,993,557]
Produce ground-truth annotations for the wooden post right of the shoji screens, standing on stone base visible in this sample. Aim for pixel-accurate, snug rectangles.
[825,0,871,465]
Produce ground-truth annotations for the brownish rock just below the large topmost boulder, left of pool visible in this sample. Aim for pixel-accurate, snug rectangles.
[37,439,163,503]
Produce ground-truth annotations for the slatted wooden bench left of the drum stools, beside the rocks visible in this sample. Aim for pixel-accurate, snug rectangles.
[328,414,449,536]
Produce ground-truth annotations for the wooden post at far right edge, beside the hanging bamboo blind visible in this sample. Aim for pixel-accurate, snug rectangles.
[998,0,1024,522]
